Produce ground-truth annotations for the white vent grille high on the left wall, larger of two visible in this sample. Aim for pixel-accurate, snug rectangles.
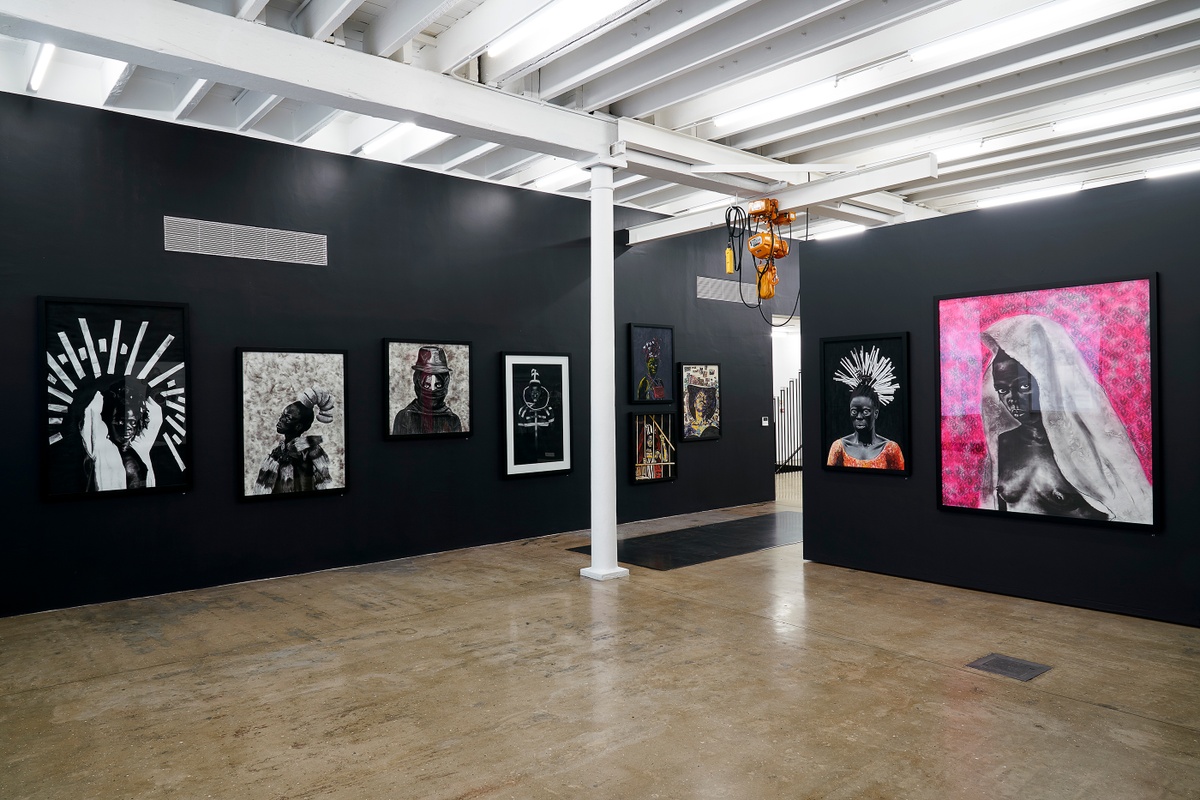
[162,217,329,266]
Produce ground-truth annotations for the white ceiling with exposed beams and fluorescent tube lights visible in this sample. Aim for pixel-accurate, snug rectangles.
[0,0,1200,240]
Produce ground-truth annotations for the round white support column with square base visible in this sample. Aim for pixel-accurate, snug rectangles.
[580,164,629,581]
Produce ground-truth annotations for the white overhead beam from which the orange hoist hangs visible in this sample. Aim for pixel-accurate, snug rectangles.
[629,154,937,245]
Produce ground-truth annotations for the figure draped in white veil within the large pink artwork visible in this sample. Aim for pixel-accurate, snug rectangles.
[980,314,1153,524]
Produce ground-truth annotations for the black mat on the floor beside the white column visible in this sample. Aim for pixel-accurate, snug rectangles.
[569,511,804,570]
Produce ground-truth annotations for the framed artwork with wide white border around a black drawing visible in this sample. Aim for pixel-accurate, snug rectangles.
[500,353,571,477]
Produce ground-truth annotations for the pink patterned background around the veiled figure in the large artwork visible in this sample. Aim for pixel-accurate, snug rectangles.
[938,279,1152,509]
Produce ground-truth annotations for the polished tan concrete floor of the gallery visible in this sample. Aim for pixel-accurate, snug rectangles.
[0,479,1200,800]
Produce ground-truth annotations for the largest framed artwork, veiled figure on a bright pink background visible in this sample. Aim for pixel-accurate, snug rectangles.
[937,277,1160,529]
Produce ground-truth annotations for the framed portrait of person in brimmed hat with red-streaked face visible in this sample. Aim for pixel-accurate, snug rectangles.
[383,339,470,439]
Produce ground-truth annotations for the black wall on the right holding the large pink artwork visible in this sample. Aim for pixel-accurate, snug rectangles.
[792,175,1200,625]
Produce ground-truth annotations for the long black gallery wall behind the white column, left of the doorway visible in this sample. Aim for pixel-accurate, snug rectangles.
[0,95,774,614]
